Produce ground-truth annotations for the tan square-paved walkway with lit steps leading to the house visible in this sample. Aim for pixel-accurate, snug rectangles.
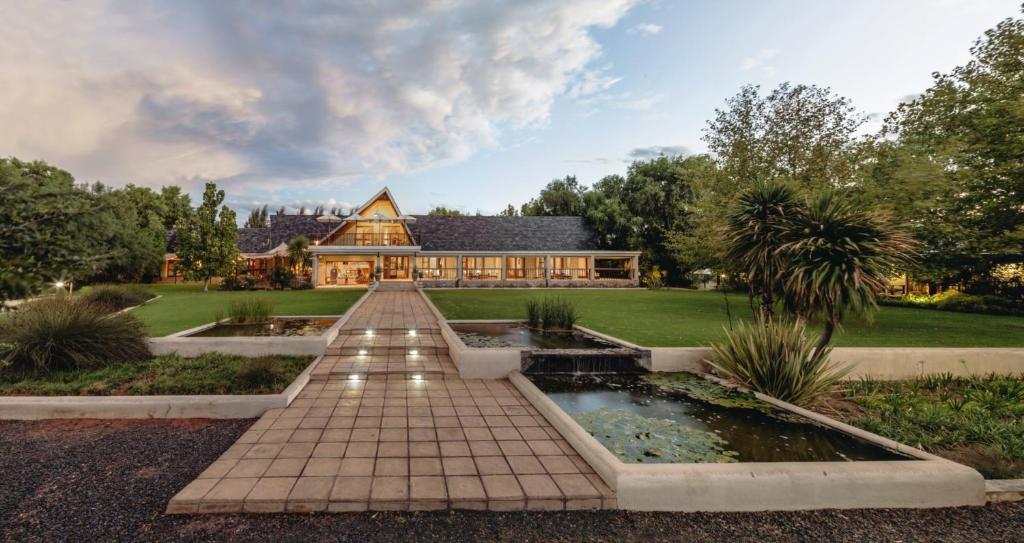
[167,284,614,513]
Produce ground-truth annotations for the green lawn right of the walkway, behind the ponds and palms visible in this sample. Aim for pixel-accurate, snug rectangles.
[425,289,1024,347]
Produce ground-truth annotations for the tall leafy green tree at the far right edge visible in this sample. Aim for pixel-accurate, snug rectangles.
[868,8,1024,295]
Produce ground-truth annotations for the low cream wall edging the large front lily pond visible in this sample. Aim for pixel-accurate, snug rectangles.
[509,373,985,511]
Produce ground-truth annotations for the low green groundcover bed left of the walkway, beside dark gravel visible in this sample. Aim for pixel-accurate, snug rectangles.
[0,352,312,395]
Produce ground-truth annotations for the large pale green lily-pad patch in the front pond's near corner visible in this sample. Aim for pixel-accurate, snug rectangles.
[572,408,736,463]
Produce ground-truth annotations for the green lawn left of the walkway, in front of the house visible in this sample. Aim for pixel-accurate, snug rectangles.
[131,285,366,337]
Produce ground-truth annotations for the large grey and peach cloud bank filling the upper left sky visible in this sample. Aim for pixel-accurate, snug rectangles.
[0,0,637,191]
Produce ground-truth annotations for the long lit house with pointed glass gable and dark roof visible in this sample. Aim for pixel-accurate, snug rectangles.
[161,187,640,288]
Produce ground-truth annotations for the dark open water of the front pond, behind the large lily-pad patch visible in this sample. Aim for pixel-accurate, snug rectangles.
[529,375,908,462]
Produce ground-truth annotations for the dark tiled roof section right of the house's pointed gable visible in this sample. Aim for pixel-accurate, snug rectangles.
[410,215,600,251]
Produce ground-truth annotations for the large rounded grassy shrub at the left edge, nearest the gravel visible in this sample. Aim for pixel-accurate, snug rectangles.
[0,299,151,374]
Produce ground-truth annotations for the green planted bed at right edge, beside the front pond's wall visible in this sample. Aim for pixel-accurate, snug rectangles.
[816,374,1024,478]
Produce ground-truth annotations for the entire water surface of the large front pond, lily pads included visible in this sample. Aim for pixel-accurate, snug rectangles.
[529,374,907,463]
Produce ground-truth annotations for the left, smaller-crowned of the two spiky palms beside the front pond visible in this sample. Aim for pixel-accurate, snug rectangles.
[725,181,797,325]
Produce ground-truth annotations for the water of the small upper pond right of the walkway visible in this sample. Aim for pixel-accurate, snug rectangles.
[451,323,618,349]
